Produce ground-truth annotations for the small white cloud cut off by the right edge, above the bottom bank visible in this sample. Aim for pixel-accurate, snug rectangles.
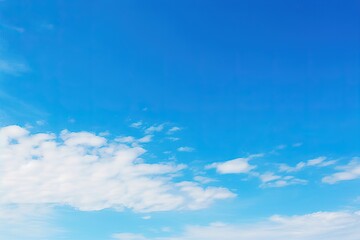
[322,157,360,184]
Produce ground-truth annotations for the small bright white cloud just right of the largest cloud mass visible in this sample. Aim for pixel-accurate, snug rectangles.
[206,154,263,174]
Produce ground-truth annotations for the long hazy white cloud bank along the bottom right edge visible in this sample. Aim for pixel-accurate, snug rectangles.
[114,212,360,240]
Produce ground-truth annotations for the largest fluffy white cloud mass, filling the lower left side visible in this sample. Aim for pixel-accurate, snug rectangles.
[0,126,234,212]
